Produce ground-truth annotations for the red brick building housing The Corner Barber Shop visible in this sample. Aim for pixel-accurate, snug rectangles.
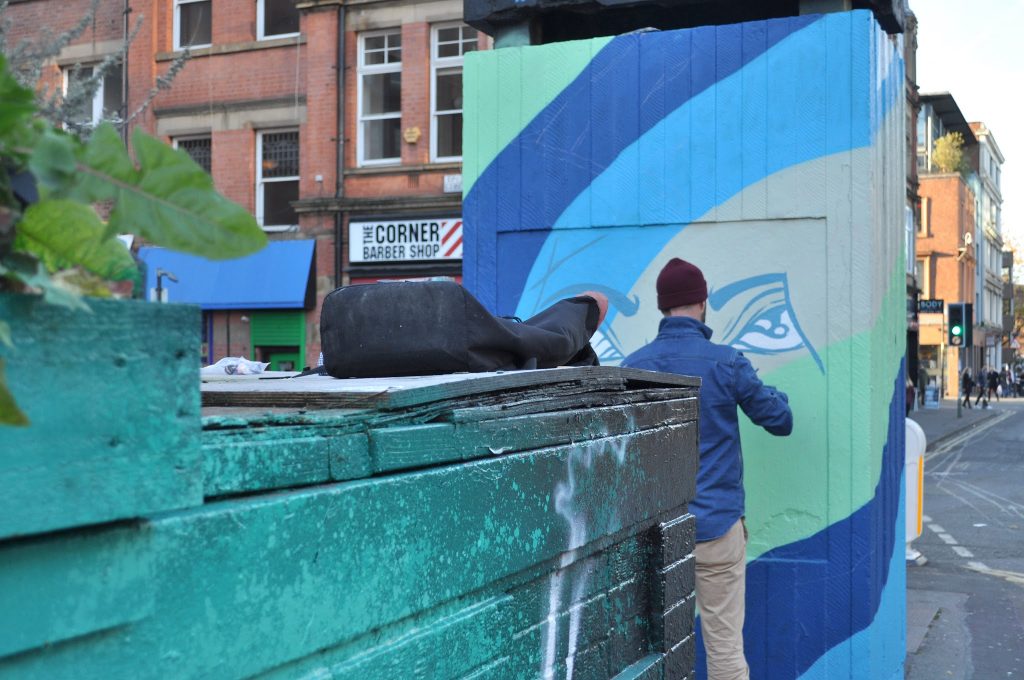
[7,0,490,369]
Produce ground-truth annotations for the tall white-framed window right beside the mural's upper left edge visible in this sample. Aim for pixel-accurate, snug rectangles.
[430,25,477,161]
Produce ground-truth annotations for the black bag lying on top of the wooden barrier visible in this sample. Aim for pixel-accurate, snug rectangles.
[321,282,600,378]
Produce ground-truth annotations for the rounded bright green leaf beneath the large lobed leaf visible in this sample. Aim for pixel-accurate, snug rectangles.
[17,199,136,281]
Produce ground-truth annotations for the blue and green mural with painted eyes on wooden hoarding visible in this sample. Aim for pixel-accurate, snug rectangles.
[463,11,905,679]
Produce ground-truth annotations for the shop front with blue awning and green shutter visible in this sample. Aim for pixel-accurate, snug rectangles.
[139,240,318,371]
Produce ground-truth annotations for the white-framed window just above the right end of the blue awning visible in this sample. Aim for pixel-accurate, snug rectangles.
[256,130,299,231]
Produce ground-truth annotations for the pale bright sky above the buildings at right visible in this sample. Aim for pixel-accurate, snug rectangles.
[910,0,1024,255]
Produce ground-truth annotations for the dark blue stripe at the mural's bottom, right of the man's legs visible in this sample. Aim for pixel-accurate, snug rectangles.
[697,363,906,680]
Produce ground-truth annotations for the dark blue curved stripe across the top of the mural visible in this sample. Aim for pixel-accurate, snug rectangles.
[463,15,820,308]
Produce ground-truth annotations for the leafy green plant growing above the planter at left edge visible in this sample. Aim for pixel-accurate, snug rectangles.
[0,55,266,425]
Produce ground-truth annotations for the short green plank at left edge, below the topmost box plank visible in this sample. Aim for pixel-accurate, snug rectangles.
[0,524,156,656]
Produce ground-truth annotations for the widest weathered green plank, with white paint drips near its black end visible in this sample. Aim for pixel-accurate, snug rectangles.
[0,423,696,678]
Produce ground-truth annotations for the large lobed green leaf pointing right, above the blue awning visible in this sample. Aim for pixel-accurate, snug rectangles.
[73,124,266,259]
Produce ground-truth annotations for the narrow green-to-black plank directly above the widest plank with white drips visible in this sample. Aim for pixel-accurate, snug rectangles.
[370,397,697,472]
